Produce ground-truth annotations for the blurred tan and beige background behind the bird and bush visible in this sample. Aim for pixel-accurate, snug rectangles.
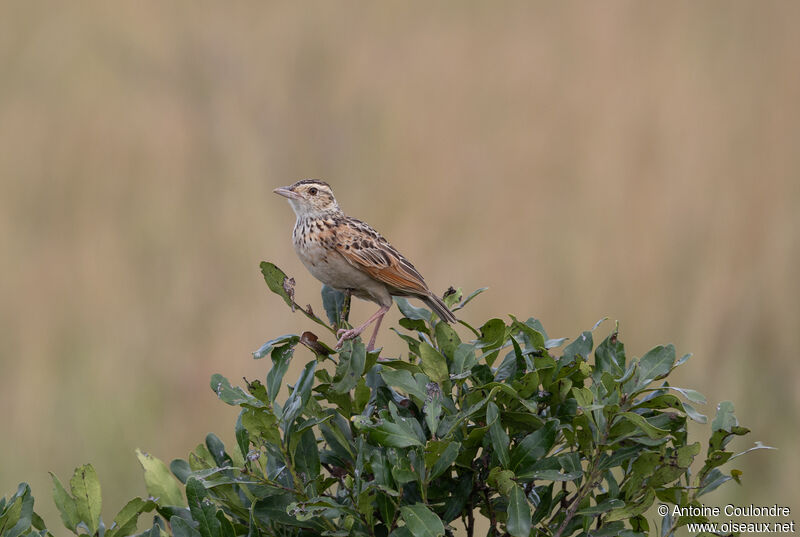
[0,1,800,528]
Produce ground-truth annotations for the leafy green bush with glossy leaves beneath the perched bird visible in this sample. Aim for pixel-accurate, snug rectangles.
[0,263,764,537]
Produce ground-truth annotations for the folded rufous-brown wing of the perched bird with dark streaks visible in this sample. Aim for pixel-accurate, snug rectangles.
[336,218,430,295]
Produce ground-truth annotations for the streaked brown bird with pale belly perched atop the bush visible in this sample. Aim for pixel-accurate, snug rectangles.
[273,179,457,352]
